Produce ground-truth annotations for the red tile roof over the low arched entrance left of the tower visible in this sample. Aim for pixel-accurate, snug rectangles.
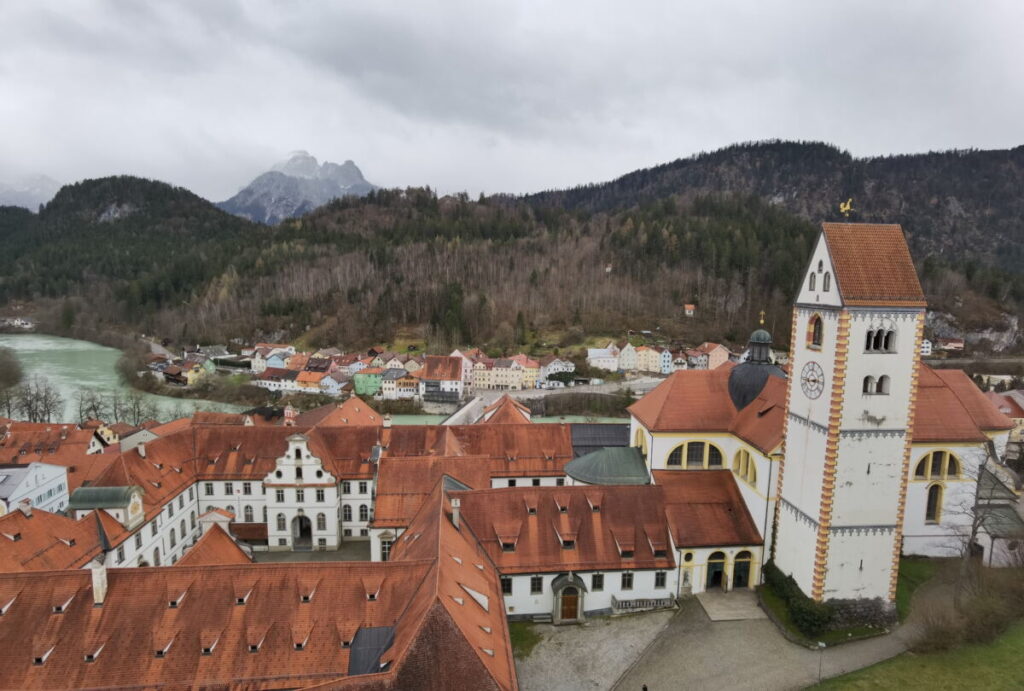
[653,470,764,548]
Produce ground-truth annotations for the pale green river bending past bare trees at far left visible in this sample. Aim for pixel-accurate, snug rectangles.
[0,334,243,423]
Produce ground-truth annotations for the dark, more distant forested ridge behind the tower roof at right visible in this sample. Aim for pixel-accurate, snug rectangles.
[527,141,1024,280]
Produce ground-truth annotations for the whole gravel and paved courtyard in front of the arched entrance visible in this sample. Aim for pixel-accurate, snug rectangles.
[516,591,925,691]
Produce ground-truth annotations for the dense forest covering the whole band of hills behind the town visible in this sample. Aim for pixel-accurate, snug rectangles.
[0,142,1024,348]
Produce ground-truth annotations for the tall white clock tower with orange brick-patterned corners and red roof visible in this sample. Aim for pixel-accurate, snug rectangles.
[774,223,926,603]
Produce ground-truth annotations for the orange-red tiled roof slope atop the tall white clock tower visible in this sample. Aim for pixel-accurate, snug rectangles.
[821,223,926,307]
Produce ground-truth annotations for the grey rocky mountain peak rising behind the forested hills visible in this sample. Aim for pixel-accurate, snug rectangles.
[217,152,377,225]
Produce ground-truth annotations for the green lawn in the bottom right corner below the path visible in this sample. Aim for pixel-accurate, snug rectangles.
[814,622,1024,691]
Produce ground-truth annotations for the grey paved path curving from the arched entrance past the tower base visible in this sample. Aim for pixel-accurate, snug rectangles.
[613,599,910,691]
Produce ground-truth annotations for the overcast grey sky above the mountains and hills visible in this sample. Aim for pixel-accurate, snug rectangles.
[0,0,1024,200]
